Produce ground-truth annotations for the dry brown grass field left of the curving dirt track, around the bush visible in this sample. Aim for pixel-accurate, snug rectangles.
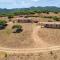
[0,23,35,48]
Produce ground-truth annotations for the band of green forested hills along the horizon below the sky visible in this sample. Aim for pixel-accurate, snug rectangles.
[0,6,60,16]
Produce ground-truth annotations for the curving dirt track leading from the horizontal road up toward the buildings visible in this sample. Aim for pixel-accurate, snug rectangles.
[32,26,49,48]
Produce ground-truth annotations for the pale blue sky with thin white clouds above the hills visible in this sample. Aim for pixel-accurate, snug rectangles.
[0,0,60,9]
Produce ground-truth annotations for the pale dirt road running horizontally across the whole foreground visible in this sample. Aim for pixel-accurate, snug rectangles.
[0,46,60,54]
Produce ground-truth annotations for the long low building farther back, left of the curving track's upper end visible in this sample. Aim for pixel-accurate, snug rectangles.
[12,17,39,23]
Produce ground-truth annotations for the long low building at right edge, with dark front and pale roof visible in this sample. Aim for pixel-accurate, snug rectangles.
[39,22,60,29]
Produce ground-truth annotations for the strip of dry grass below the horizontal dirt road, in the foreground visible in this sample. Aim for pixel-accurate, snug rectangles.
[0,50,60,60]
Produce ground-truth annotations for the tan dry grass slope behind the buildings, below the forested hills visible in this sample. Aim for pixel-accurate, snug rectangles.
[28,12,60,22]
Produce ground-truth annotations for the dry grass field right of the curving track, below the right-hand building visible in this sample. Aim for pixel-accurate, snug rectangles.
[38,28,60,46]
